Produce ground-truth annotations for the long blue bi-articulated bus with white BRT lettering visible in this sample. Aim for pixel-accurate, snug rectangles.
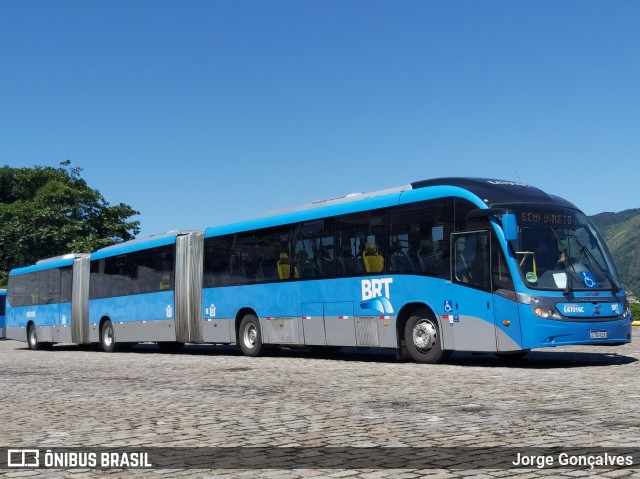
[7,178,631,363]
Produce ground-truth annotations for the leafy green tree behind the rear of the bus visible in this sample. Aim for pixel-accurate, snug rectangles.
[0,161,140,285]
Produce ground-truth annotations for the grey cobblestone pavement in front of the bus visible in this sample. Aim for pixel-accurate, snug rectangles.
[0,327,640,479]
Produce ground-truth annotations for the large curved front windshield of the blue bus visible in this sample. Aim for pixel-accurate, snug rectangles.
[510,205,621,292]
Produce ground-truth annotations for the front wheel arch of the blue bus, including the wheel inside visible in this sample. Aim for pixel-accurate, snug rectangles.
[397,303,451,363]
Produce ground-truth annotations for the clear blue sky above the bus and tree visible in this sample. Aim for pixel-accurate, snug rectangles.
[0,0,640,235]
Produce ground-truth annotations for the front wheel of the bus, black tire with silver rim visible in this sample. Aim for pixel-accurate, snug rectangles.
[404,311,451,364]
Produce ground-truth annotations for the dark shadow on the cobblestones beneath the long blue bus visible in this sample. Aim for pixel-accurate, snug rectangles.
[16,343,638,369]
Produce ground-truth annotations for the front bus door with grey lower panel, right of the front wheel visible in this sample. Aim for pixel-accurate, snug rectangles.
[448,230,497,351]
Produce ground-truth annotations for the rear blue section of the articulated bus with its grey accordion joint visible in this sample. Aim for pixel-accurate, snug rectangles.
[6,254,89,350]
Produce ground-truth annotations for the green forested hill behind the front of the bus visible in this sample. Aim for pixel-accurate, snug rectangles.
[590,208,640,295]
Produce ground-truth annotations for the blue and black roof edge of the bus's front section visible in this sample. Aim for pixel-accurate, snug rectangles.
[205,177,575,238]
